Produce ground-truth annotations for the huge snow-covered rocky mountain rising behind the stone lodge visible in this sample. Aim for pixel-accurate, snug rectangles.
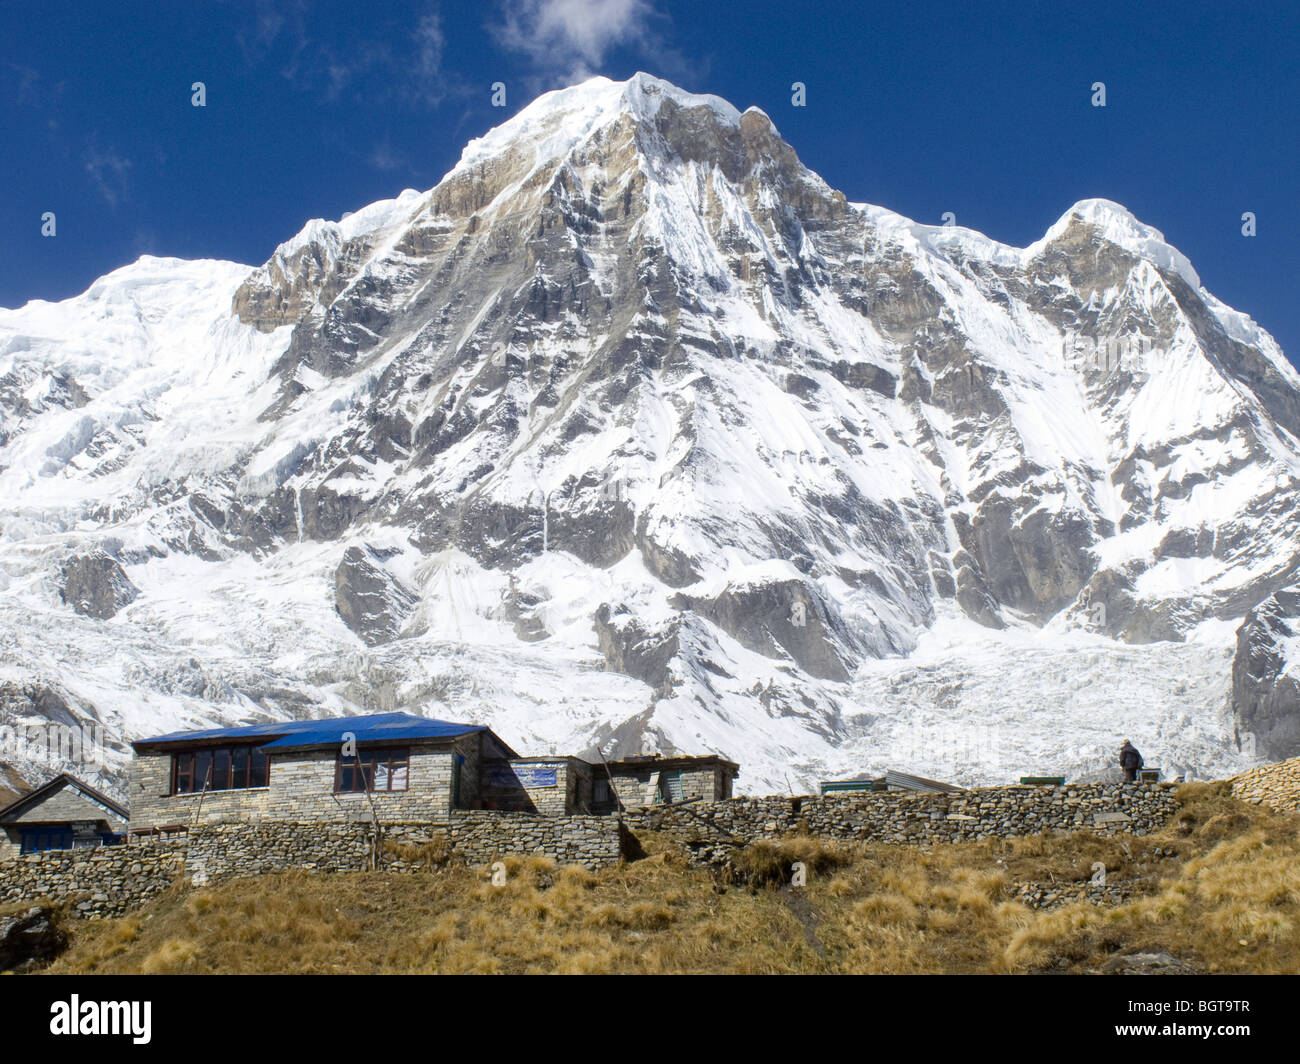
[0,74,1300,792]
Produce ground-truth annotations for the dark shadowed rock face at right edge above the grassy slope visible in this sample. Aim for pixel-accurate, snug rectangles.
[1232,587,1300,760]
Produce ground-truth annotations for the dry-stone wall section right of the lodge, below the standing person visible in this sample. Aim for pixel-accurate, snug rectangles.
[624,783,1178,845]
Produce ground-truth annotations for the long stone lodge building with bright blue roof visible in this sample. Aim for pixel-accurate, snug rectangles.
[129,713,740,834]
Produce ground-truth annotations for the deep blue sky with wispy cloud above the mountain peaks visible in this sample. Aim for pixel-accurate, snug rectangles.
[0,0,1300,363]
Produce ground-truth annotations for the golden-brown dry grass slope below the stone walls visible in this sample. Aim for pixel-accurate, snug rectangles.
[38,784,1300,974]
